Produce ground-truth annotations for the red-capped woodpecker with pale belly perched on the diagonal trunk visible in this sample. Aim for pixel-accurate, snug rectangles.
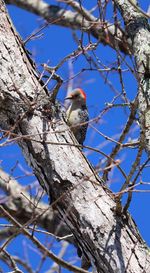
[66,88,89,145]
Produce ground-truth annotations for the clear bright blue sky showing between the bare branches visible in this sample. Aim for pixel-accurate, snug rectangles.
[0,0,150,272]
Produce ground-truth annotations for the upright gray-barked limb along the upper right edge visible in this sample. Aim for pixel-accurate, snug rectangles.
[115,0,150,155]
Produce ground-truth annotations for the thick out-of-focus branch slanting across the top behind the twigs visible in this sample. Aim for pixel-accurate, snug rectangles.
[5,0,131,54]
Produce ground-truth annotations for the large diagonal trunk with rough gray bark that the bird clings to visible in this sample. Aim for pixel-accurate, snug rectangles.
[0,0,150,273]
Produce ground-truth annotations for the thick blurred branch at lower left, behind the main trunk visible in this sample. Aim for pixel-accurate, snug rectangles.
[0,169,73,243]
